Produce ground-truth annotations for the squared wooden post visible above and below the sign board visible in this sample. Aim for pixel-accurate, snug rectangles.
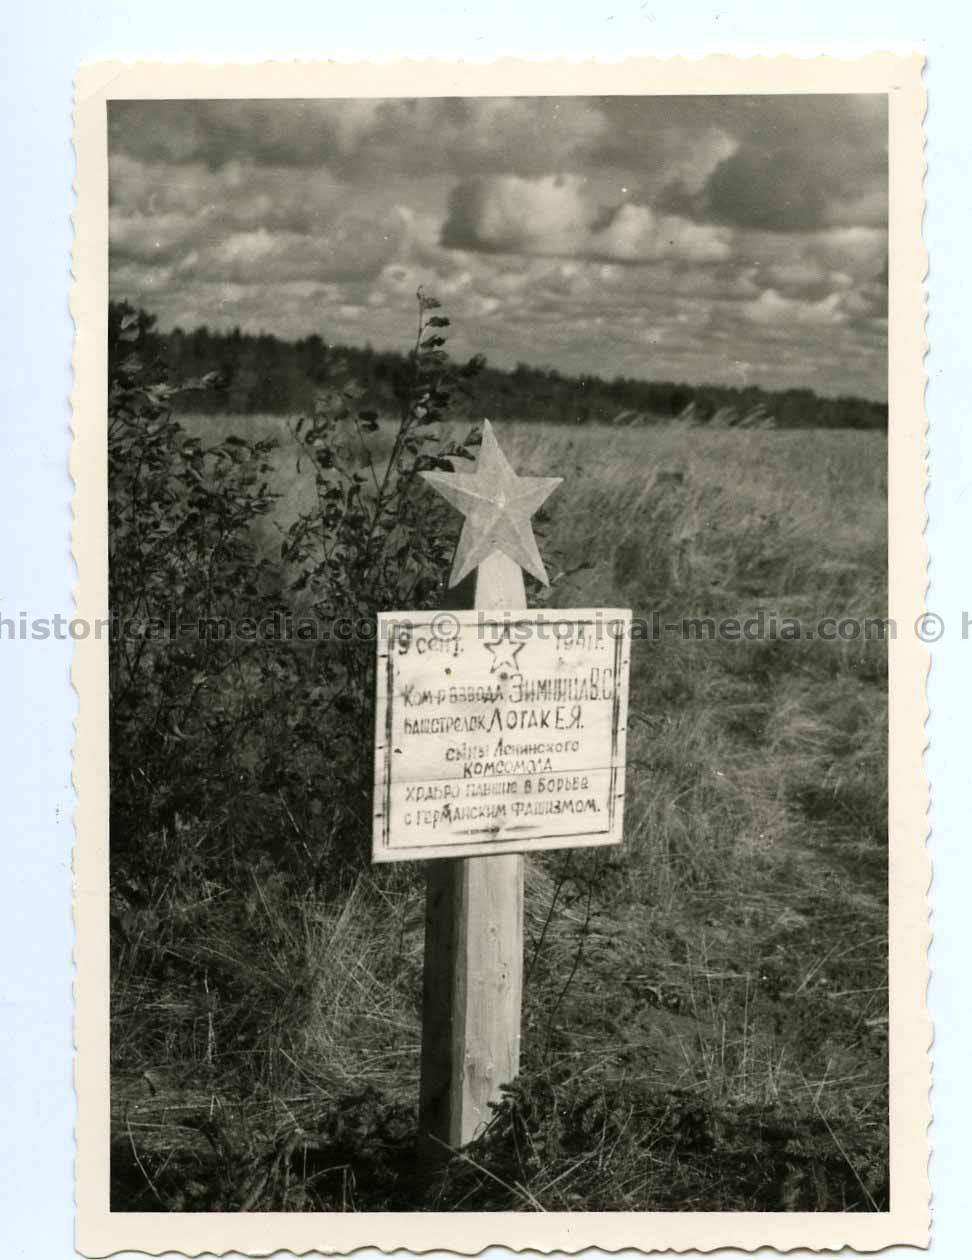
[419,552,526,1169]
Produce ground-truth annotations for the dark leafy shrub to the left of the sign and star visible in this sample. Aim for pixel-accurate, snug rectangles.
[108,292,479,891]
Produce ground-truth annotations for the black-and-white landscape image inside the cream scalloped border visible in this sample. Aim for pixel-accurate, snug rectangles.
[70,56,920,1249]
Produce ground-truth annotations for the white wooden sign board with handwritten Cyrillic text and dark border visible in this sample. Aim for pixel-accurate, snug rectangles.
[372,609,630,862]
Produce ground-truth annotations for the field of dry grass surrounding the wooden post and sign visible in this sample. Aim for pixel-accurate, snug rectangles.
[111,417,888,1211]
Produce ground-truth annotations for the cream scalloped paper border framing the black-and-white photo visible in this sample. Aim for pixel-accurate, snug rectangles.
[71,53,932,1256]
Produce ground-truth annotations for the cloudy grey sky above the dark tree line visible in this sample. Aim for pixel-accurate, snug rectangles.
[110,96,888,399]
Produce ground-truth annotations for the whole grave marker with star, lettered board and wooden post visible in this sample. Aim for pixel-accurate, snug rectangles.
[373,421,630,1166]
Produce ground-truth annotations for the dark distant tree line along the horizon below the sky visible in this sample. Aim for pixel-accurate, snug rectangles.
[108,301,888,430]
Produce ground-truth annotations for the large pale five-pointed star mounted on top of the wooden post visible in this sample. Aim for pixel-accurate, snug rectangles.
[422,420,564,586]
